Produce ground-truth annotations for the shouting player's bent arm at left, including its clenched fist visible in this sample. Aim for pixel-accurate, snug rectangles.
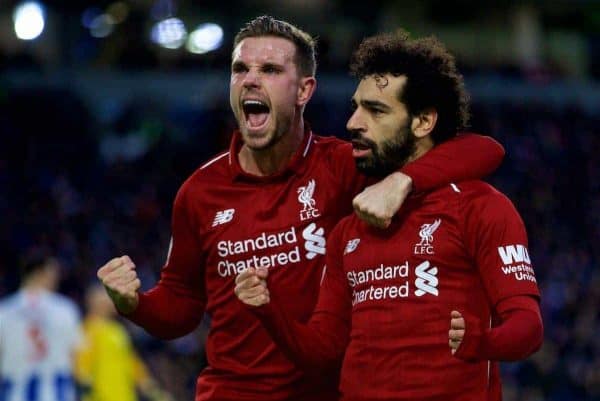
[98,184,206,339]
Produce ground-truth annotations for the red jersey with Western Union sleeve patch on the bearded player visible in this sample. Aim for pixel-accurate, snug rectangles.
[302,181,539,401]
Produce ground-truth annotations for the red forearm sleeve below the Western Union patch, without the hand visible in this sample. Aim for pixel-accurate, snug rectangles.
[454,295,544,361]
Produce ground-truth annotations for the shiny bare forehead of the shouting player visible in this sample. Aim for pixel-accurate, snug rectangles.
[232,36,296,64]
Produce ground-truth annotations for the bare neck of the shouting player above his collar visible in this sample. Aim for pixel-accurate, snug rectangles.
[238,119,304,176]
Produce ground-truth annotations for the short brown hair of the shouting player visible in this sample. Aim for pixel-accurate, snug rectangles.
[233,15,317,76]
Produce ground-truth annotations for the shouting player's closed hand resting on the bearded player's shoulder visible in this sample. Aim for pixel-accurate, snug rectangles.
[352,172,412,228]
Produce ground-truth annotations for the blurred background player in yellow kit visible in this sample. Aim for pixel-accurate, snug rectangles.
[76,285,171,401]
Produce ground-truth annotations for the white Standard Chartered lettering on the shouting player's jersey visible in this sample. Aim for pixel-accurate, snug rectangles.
[217,227,300,277]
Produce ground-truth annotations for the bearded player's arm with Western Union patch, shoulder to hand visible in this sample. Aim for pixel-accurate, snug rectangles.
[448,185,543,361]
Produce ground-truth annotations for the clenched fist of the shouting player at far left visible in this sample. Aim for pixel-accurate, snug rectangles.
[97,255,141,314]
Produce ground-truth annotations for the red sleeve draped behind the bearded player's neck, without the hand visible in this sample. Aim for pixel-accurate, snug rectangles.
[400,133,504,193]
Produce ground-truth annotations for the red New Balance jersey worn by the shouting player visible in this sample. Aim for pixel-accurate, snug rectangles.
[129,131,503,401]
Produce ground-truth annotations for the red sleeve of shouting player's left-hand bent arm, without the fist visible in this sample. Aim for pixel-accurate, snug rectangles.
[125,184,206,339]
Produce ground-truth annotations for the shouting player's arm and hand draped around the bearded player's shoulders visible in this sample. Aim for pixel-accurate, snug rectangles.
[352,133,504,228]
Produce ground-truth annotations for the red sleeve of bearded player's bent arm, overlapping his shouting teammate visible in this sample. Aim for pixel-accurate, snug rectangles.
[251,220,352,373]
